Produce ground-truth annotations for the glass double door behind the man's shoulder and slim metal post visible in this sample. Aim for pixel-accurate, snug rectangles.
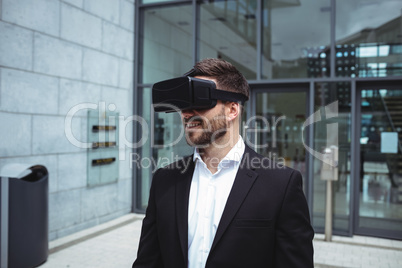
[247,82,352,235]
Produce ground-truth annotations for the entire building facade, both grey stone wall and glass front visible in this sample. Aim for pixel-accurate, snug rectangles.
[0,0,402,240]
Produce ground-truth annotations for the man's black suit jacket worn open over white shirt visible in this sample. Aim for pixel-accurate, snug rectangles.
[133,146,314,268]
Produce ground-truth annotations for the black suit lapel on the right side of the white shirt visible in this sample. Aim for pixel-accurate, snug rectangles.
[210,146,258,252]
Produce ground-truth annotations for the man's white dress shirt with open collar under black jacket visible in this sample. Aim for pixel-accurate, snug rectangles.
[188,136,245,268]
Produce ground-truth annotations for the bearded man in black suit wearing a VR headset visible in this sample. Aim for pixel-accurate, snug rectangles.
[133,59,314,268]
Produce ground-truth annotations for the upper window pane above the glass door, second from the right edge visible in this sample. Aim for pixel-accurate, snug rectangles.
[261,0,331,79]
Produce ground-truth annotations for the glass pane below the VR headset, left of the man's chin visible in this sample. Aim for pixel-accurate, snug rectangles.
[135,88,193,210]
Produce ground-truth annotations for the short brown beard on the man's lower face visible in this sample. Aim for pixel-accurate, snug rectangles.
[185,108,228,147]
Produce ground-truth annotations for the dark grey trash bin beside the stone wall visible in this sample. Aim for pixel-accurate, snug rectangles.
[0,164,49,268]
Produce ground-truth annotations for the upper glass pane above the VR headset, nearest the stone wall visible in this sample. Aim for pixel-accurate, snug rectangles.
[140,5,193,83]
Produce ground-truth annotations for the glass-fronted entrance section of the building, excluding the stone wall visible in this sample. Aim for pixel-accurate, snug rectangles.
[134,0,402,239]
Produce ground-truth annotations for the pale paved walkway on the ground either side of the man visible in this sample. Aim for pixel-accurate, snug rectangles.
[40,214,402,268]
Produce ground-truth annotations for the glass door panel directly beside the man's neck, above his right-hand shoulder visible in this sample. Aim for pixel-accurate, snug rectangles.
[248,90,308,187]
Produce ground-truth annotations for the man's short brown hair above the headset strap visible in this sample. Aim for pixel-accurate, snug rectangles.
[191,58,250,98]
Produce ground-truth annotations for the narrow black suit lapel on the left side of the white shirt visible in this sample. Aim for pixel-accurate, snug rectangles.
[176,156,195,264]
